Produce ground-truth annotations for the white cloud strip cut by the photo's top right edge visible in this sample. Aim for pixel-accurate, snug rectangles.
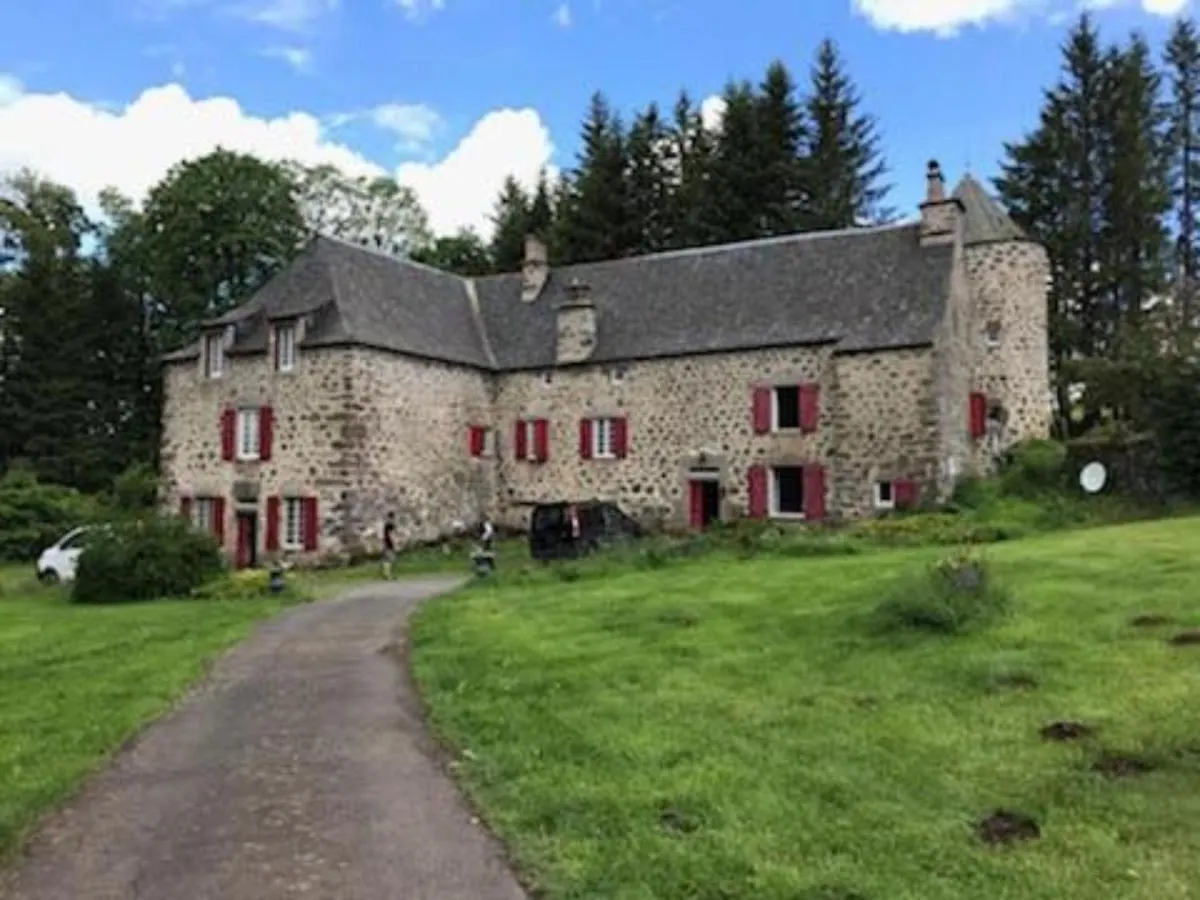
[852,0,1189,37]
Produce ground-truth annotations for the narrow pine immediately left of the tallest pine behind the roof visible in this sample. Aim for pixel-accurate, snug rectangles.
[757,60,808,235]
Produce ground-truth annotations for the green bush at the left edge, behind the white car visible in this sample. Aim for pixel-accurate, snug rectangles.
[0,469,96,562]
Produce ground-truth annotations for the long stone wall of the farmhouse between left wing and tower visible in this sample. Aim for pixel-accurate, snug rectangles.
[496,348,934,527]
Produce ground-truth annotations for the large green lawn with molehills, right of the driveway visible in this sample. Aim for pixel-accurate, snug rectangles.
[413,518,1200,900]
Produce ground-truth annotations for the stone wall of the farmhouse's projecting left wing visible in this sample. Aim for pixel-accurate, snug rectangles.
[162,348,494,564]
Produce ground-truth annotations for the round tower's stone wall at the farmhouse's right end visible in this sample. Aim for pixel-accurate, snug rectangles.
[966,241,1050,445]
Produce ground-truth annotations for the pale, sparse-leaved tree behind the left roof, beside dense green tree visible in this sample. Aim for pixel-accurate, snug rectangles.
[288,163,432,257]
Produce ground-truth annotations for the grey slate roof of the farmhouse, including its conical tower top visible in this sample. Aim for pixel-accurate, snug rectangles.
[167,176,1024,371]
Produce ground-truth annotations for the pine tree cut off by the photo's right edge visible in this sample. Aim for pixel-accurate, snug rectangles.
[1165,18,1200,346]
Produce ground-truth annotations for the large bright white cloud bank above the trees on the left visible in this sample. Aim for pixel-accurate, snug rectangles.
[0,76,557,235]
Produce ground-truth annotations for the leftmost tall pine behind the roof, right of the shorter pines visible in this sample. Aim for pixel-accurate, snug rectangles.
[556,92,636,263]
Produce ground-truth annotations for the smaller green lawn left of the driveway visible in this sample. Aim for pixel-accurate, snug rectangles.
[0,566,294,856]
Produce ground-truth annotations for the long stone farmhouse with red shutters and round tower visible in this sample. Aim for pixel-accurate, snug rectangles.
[162,163,1050,565]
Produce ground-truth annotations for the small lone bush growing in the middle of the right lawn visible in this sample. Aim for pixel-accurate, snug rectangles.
[875,550,1009,635]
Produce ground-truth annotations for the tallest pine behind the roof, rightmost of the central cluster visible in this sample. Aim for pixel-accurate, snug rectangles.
[804,38,892,230]
